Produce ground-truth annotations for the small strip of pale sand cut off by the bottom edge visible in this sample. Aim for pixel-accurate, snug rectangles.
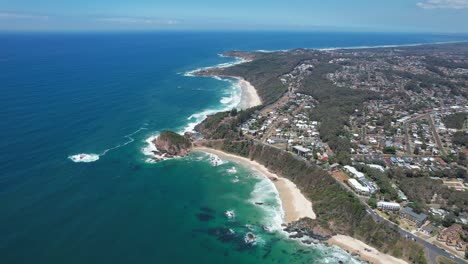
[327,235,407,264]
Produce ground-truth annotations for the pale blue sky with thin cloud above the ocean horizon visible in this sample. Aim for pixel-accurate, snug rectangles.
[0,0,468,33]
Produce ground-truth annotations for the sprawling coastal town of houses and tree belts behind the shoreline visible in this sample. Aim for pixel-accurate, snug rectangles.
[186,42,468,262]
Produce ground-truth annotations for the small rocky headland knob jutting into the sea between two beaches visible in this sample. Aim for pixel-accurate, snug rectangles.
[153,131,192,158]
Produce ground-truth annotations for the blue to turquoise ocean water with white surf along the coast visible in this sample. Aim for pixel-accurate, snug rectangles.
[0,32,468,263]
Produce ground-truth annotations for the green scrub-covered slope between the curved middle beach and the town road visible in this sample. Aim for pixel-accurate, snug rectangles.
[196,113,425,263]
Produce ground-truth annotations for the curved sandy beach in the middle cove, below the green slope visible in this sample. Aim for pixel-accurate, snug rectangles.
[194,147,316,223]
